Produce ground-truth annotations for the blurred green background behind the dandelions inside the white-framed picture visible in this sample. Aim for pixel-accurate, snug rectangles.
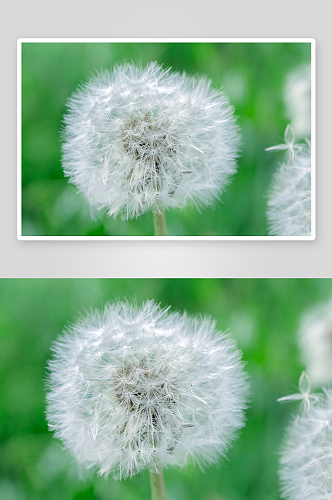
[22,43,310,236]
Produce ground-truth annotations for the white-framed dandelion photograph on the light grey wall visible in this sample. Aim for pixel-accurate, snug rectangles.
[17,39,316,240]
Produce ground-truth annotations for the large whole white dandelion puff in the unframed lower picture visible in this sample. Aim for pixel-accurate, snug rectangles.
[47,301,248,478]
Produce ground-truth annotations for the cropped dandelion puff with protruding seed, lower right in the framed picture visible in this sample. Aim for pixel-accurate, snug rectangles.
[266,125,311,236]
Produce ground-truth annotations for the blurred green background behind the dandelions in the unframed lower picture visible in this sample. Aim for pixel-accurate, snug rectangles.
[0,279,332,500]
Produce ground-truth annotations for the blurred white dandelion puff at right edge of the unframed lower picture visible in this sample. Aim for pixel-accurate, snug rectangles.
[299,300,332,387]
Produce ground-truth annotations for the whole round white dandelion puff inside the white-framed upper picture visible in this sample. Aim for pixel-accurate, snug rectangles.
[62,62,239,219]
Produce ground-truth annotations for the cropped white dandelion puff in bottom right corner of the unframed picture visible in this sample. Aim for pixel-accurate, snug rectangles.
[279,376,332,500]
